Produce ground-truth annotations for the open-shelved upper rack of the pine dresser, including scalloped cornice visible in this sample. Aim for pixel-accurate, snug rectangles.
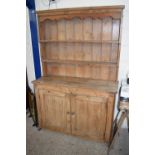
[37,6,124,81]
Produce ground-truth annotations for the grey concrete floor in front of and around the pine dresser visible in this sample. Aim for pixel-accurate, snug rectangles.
[26,115,129,155]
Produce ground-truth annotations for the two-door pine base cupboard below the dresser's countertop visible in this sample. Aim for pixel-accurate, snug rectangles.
[35,76,115,142]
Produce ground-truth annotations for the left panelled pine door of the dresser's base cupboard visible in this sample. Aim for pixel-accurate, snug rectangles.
[39,90,71,133]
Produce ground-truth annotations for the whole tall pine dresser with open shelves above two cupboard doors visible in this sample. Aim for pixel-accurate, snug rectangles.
[33,6,124,142]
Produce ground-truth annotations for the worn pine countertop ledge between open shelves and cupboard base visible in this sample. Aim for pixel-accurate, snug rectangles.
[32,76,118,93]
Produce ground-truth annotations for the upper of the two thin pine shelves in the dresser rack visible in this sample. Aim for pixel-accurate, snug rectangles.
[40,40,120,44]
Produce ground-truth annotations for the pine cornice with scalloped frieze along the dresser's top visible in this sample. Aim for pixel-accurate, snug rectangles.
[37,5,124,22]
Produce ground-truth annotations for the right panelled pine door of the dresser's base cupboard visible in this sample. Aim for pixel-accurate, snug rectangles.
[71,95,108,140]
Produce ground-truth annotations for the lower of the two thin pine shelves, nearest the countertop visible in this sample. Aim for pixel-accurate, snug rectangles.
[42,59,117,65]
